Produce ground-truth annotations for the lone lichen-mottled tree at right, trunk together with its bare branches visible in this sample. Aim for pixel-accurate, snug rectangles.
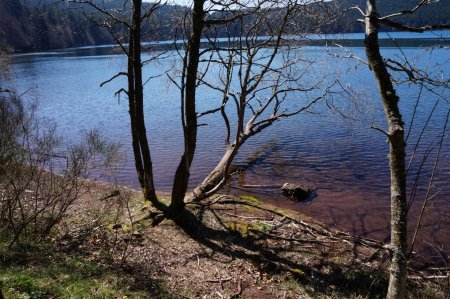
[358,0,449,298]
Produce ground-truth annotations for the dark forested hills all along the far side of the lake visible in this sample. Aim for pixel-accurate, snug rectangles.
[0,0,450,51]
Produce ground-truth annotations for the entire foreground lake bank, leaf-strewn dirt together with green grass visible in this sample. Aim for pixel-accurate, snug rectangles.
[0,181,445,299]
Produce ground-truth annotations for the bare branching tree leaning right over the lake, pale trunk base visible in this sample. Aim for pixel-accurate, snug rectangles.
[186,1,333,201]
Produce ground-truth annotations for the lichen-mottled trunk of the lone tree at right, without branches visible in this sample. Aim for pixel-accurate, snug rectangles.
[365,0,407,299]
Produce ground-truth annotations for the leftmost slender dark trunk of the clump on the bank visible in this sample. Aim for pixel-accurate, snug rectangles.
[128,0,158,204]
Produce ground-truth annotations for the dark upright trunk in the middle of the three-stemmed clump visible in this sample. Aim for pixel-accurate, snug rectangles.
[170,0,204,210]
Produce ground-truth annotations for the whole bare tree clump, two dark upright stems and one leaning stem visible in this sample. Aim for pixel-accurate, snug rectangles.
[66,0,334,217]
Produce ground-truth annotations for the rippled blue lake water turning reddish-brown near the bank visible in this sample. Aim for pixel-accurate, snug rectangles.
[7,35,450,260]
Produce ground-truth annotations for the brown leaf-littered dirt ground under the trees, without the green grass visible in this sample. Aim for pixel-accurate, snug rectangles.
[40,184,446,298]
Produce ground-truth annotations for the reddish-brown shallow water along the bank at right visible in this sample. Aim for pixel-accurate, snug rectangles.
[226,171,450,264]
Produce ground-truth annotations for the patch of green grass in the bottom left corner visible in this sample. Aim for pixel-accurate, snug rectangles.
[0,258,146,299]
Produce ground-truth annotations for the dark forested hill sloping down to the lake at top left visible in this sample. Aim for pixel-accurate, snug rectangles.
[0,0,112,51]
